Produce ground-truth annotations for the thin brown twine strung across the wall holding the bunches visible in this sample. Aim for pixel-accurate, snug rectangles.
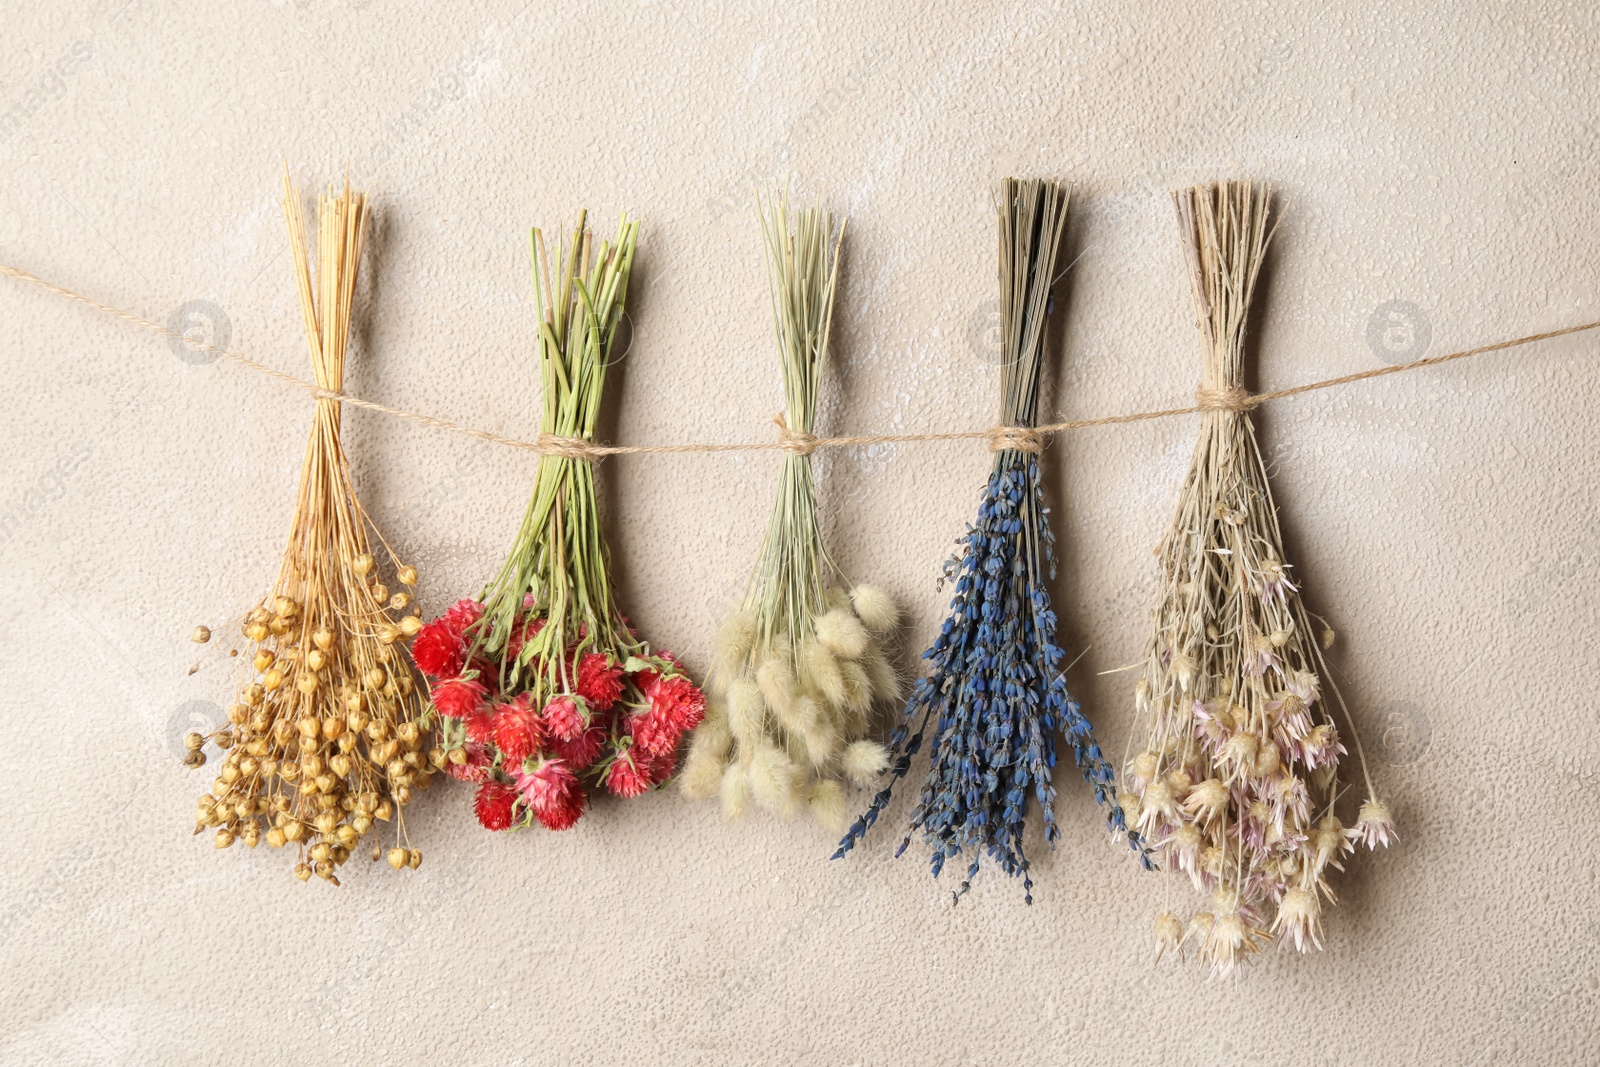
[0,264,1600,459]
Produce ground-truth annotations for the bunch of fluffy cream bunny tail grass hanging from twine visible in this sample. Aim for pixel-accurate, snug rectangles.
[682,197,899,833]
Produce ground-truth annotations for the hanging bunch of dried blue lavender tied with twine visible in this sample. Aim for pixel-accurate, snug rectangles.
[835,179,1139,904]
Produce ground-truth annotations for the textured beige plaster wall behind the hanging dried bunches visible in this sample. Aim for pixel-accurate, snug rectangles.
[0,0,1600,1064]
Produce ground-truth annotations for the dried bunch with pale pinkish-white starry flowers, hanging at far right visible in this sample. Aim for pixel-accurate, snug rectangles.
[1120,181,1395,976]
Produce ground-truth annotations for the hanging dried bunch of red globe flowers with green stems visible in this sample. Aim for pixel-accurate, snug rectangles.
[411,214,706,830]
